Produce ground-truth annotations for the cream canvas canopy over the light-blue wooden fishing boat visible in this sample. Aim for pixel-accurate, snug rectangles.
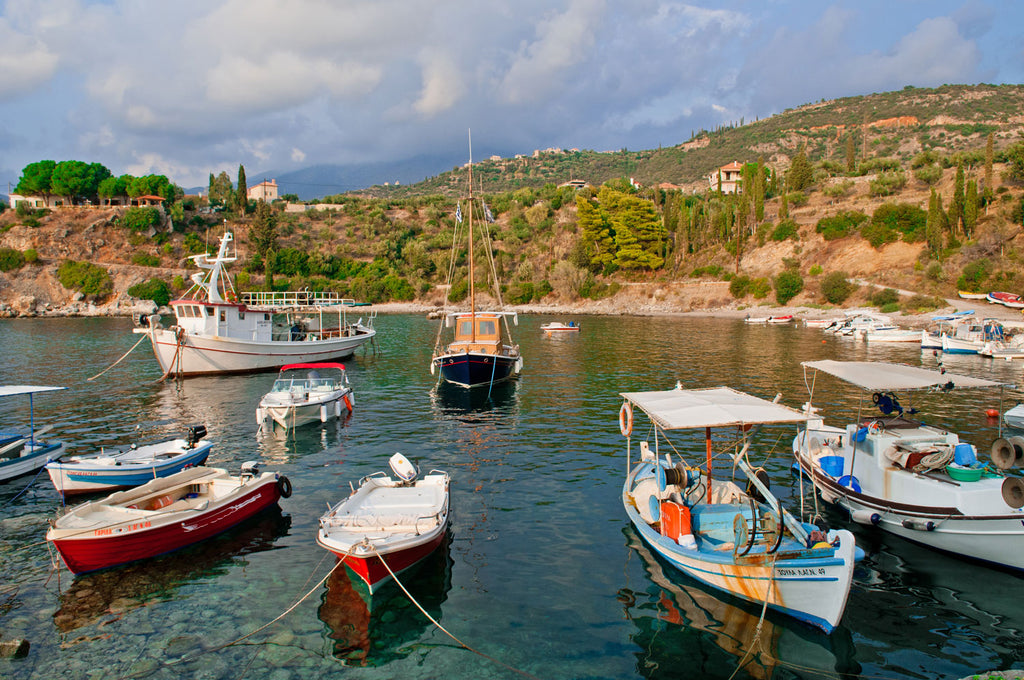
[622,387,807,430]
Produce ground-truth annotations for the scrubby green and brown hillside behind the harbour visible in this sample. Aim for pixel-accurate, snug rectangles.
[0,85,1024,315]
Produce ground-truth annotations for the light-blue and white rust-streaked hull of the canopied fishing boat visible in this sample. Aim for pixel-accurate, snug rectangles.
[623,464,856,632]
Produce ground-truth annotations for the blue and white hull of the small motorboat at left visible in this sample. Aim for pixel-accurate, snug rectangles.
[46,441,213,496]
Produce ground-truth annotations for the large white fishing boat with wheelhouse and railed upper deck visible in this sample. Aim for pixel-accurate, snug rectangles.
[133,231,377,377]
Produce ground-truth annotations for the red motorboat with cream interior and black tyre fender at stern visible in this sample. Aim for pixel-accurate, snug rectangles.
[46,462,292,573]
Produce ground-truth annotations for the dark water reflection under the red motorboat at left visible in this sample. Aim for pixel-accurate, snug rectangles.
[53,507,292,633]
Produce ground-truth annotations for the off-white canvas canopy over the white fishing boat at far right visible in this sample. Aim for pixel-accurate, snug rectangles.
[802,359,1005,392]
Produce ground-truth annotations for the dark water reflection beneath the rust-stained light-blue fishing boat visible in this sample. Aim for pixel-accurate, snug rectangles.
[620,526,860,680]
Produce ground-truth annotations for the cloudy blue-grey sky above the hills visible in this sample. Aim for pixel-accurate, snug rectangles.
[0,0,1024,194]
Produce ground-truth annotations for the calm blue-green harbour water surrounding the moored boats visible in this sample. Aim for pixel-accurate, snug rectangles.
[0,315,1024,680]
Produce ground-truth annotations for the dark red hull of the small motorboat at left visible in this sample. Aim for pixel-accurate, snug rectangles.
[47,475,281,573]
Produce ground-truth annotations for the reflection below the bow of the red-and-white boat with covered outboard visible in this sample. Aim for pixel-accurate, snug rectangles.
[317,538,453,666]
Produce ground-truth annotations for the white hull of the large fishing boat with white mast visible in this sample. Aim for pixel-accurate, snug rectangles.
[136,327,377,377]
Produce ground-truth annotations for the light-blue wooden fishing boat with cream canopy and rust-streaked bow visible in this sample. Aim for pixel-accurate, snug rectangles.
[620,386,861,631]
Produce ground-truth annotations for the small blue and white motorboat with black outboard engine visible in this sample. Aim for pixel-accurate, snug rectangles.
[46,425,213,496]
